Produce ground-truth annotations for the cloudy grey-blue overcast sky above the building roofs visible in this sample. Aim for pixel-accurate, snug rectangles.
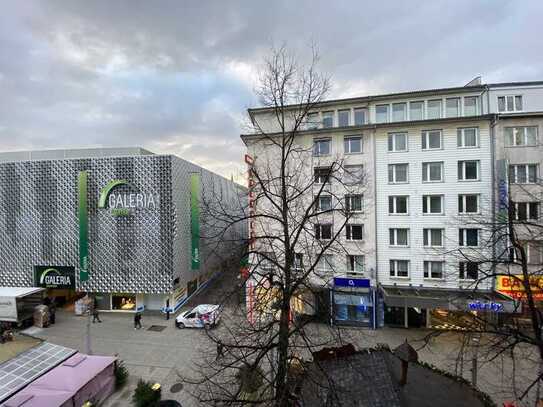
[0,0,543,182]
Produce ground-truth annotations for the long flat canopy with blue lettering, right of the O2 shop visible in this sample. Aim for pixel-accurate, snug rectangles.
[379,286,519,312]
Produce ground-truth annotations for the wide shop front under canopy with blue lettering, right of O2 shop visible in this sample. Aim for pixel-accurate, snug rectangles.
[380,286,518,330]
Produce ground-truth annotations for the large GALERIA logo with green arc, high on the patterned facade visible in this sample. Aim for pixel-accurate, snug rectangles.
[98,179,158,216]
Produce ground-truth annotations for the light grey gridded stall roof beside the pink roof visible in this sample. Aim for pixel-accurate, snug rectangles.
[0,342,77,402]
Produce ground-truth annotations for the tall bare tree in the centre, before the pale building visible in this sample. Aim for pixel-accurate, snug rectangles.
[188,47,369,406]
